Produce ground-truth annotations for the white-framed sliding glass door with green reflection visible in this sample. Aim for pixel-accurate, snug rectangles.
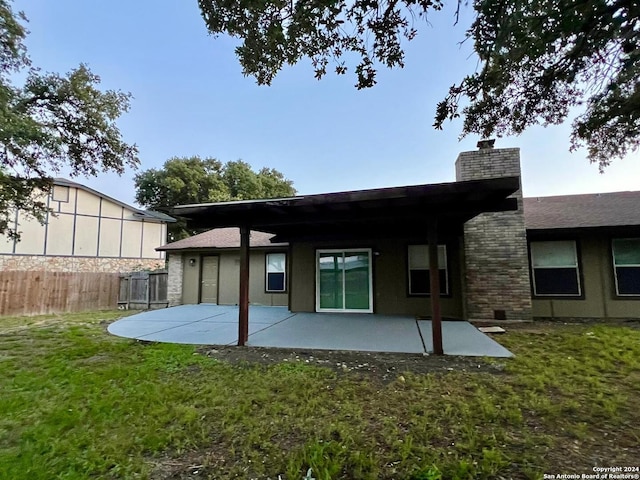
[316,249,373,313]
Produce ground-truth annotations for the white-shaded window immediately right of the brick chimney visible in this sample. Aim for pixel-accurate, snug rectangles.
[530,240,581,297]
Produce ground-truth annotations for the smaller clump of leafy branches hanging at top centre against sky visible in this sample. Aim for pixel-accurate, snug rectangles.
[198,0,443,88]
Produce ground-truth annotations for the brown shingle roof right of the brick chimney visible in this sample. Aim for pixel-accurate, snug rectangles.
[524,191,640,230]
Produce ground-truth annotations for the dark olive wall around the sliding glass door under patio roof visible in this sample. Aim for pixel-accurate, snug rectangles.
[290,239,463,318]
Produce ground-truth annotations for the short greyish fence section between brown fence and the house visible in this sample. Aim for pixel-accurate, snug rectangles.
[118,271,169,310]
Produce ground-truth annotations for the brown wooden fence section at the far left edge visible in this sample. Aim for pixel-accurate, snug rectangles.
[0,271,120,315]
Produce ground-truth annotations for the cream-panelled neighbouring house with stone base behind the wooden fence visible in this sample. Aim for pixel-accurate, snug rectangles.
[0,179,175,273]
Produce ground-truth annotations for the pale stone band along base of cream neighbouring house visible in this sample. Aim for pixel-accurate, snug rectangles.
[0,255,165,273]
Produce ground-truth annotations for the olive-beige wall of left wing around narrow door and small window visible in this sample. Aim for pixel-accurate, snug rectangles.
[175,250,289,306]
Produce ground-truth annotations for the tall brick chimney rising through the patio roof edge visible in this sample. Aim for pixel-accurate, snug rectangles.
[456,144,532,321]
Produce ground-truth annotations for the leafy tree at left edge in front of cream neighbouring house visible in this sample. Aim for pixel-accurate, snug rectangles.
[0,0,138,237]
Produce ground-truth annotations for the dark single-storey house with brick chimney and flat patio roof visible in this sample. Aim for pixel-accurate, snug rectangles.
[164,147,640,321]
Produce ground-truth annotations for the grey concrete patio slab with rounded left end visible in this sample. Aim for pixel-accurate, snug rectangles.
[108,304,513,357]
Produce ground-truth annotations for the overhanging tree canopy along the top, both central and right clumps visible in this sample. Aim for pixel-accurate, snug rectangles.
[198,0,640,168]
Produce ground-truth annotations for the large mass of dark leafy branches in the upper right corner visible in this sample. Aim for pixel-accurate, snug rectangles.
[436,0,640,169]
